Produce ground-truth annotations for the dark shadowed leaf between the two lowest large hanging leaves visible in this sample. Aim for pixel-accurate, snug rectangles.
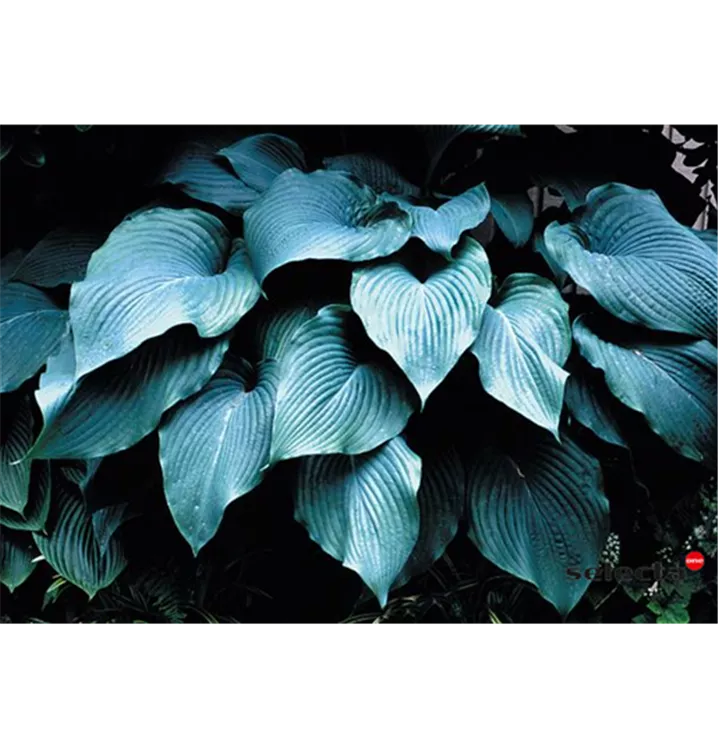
[394,448,466,588]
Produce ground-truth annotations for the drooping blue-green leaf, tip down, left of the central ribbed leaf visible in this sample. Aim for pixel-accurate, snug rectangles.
[160,357,278,555]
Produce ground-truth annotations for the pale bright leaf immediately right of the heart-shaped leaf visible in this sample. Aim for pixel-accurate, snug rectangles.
[471,273,571,438]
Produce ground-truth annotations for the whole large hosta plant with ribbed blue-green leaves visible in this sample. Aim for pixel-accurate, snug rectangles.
[0,121,718,617]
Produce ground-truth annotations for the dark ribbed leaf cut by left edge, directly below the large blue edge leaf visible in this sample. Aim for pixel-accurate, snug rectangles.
[0,394,34,514]
